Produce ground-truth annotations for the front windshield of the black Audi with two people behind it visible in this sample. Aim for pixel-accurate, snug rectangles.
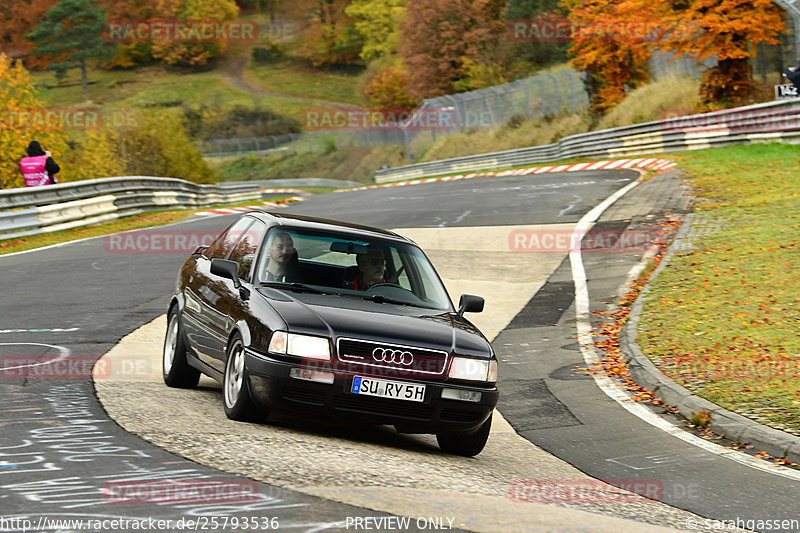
[255,228,452,311]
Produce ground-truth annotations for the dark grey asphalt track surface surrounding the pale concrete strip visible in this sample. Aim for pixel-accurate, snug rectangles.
[0,171,800,531]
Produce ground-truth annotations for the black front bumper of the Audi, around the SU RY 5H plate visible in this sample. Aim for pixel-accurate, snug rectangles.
[245,350,499,433]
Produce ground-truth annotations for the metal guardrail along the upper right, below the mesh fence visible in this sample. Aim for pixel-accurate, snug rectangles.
[375,99,800,183]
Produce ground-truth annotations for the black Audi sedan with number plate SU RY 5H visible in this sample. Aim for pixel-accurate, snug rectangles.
[163,212,499,456]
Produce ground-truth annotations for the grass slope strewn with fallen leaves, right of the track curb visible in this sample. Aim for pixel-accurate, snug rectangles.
[639,144,800,434]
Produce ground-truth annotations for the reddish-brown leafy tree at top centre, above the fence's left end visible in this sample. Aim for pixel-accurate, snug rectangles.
[400,0,504,100]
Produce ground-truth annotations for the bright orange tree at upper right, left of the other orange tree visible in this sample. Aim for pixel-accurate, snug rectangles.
[562,0,659,113]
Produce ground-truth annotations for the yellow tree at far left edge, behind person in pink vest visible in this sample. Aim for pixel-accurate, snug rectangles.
[0,53,67,189]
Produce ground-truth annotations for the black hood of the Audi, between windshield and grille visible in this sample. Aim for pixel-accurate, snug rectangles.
[259,290,491,357]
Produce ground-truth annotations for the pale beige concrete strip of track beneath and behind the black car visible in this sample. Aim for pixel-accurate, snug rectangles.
[95,217,720,533]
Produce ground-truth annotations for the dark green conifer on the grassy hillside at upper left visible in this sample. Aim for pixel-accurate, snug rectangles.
[26,0,111,100]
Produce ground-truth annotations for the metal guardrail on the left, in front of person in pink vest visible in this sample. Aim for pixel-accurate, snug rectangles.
[0,176,261,240]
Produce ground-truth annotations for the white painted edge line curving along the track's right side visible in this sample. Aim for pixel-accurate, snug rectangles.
[569,176,800,481]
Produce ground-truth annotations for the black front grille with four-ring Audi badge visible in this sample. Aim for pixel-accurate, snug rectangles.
[336,338,447,379]
